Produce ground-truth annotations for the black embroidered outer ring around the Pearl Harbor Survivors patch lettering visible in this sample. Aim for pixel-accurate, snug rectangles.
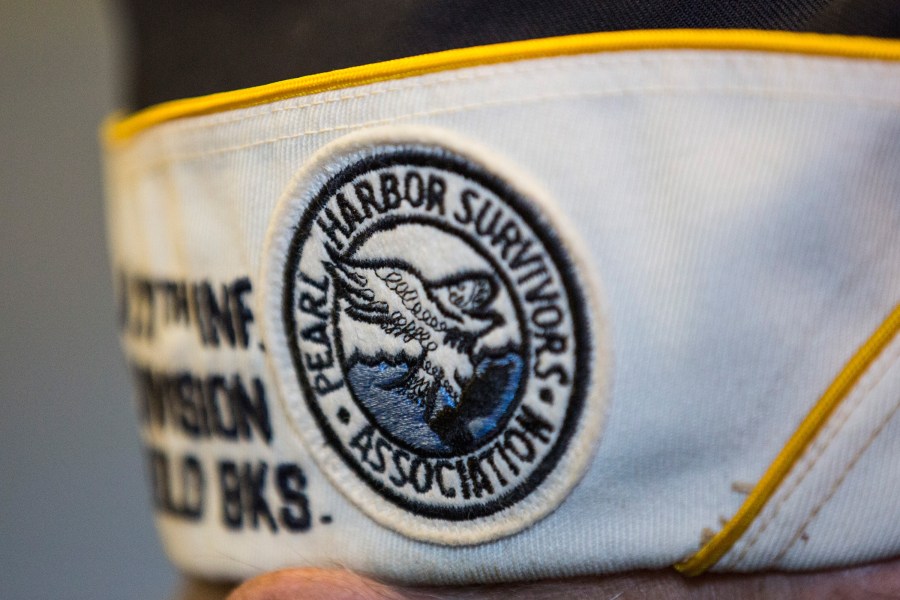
[281,149,595,522]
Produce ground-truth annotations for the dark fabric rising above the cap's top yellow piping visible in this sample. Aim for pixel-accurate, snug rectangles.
[124,0,900,108]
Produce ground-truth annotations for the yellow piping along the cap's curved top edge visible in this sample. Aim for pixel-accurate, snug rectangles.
[103,29,900,143]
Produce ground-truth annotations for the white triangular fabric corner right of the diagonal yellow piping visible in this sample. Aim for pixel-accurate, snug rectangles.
[716,324,900,571]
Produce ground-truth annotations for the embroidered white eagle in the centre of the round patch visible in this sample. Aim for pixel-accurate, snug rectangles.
[325,249,504,423]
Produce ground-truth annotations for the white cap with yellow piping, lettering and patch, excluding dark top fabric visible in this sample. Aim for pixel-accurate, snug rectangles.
[106,31,900,584]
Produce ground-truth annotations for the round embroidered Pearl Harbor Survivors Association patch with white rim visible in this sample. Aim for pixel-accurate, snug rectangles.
[265,128,608,544]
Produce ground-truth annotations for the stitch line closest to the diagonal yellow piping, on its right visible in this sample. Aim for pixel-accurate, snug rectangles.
[727,336,900,568]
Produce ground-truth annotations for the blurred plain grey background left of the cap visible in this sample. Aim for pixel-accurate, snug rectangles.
[0,0,177,600]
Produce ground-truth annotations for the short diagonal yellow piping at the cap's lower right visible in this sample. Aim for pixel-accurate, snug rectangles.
[675,304,900,576]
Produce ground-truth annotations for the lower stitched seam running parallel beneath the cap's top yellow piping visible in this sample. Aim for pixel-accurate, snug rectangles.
[118,86,900,175]
